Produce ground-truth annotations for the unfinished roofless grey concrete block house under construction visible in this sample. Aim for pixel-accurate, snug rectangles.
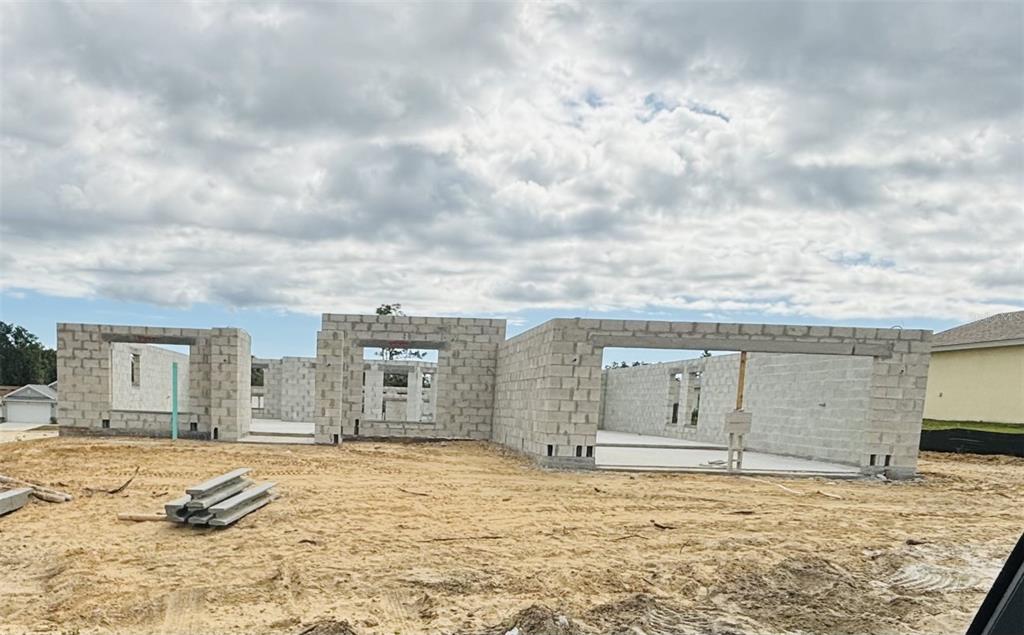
[57,313,931,477]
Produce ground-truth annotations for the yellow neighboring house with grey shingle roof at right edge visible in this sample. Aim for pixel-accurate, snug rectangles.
[925,311,1024,424]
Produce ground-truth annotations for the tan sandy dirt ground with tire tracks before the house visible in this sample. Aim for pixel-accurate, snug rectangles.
[0,438,1024,635]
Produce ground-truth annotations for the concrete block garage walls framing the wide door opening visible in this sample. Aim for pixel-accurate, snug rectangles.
[495,319,931,477]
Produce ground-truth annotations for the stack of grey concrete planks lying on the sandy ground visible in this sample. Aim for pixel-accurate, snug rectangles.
[164,467,278,526]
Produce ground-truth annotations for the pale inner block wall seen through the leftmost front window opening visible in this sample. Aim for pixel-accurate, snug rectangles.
[111,342,188,412]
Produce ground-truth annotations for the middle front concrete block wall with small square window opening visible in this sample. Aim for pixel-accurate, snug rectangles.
[314,313,505,443]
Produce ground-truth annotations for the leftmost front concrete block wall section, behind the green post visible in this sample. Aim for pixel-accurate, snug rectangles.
[57,323,249,438]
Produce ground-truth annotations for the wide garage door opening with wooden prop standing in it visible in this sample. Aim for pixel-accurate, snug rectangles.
[597,348,876,471]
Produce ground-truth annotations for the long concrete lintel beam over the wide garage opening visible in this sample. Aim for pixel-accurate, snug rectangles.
[589,333,893,357]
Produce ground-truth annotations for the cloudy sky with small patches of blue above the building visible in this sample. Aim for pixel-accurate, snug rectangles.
[0,2,1024,352]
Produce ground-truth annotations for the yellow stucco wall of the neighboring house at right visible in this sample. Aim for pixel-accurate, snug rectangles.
[925,346,1024,423]
